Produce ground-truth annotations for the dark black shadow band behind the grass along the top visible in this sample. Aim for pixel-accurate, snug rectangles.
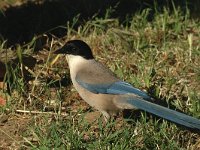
[0,0,200,46]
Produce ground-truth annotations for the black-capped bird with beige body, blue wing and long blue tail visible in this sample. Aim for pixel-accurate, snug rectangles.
[53,40,200,130]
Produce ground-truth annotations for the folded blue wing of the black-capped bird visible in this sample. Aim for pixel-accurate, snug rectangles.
[76,78,150,99]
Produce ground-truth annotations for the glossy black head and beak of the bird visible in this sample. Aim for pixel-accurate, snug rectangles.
[54,40,94,59]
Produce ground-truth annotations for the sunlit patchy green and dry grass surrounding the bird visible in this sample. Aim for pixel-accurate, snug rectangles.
[1,1,200,149]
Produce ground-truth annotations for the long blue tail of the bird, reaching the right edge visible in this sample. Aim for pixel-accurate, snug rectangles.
[118,98,200,130]
